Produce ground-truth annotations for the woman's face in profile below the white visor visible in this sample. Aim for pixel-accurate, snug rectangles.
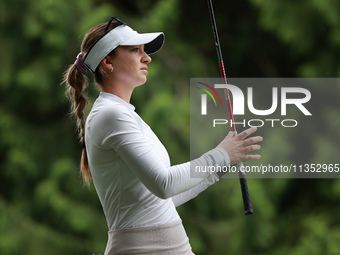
[112,45,151,88]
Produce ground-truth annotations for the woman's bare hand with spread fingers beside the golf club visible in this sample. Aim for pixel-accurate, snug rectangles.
[217,127,263,165]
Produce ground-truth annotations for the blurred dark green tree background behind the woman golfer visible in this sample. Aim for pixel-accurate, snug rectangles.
[0,0,340,255]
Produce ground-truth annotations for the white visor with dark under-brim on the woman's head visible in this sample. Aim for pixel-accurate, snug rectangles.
[85,25,164,72]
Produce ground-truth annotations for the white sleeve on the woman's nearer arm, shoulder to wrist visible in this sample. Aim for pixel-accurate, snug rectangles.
[91,107,230,199]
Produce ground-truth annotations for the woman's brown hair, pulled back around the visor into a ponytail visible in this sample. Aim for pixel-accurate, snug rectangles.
[62,22,120,185]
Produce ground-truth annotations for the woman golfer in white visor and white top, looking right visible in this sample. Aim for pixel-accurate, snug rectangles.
[65,17,262,255]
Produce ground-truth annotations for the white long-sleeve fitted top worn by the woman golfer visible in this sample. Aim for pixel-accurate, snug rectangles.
[85,92,230,230]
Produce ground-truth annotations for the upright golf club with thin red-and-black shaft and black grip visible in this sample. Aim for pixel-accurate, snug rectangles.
[208,0,253,215]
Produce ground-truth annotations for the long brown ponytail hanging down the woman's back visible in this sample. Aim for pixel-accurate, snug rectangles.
[64,55,91,185]
